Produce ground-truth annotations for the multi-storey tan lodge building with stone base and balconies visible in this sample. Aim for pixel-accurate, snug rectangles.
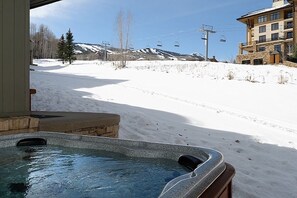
[236,0,297,65]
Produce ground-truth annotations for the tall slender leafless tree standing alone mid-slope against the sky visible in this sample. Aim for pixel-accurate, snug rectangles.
[116,11,132,68]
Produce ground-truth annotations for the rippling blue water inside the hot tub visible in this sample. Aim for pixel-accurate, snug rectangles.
[0,145,187,197]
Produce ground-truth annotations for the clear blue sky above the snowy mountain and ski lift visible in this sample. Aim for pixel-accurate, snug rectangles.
[31,0,272,60]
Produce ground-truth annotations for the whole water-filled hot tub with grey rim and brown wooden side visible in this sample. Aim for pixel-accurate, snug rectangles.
[0,132,234,198]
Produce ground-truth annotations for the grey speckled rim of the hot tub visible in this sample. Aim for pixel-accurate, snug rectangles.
[0,131,226,198]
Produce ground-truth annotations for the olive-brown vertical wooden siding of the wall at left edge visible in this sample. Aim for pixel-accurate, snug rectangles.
[0,0,30,117]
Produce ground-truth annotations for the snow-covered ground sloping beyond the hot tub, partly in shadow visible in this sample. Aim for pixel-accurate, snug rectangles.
[31,60,297,198]
